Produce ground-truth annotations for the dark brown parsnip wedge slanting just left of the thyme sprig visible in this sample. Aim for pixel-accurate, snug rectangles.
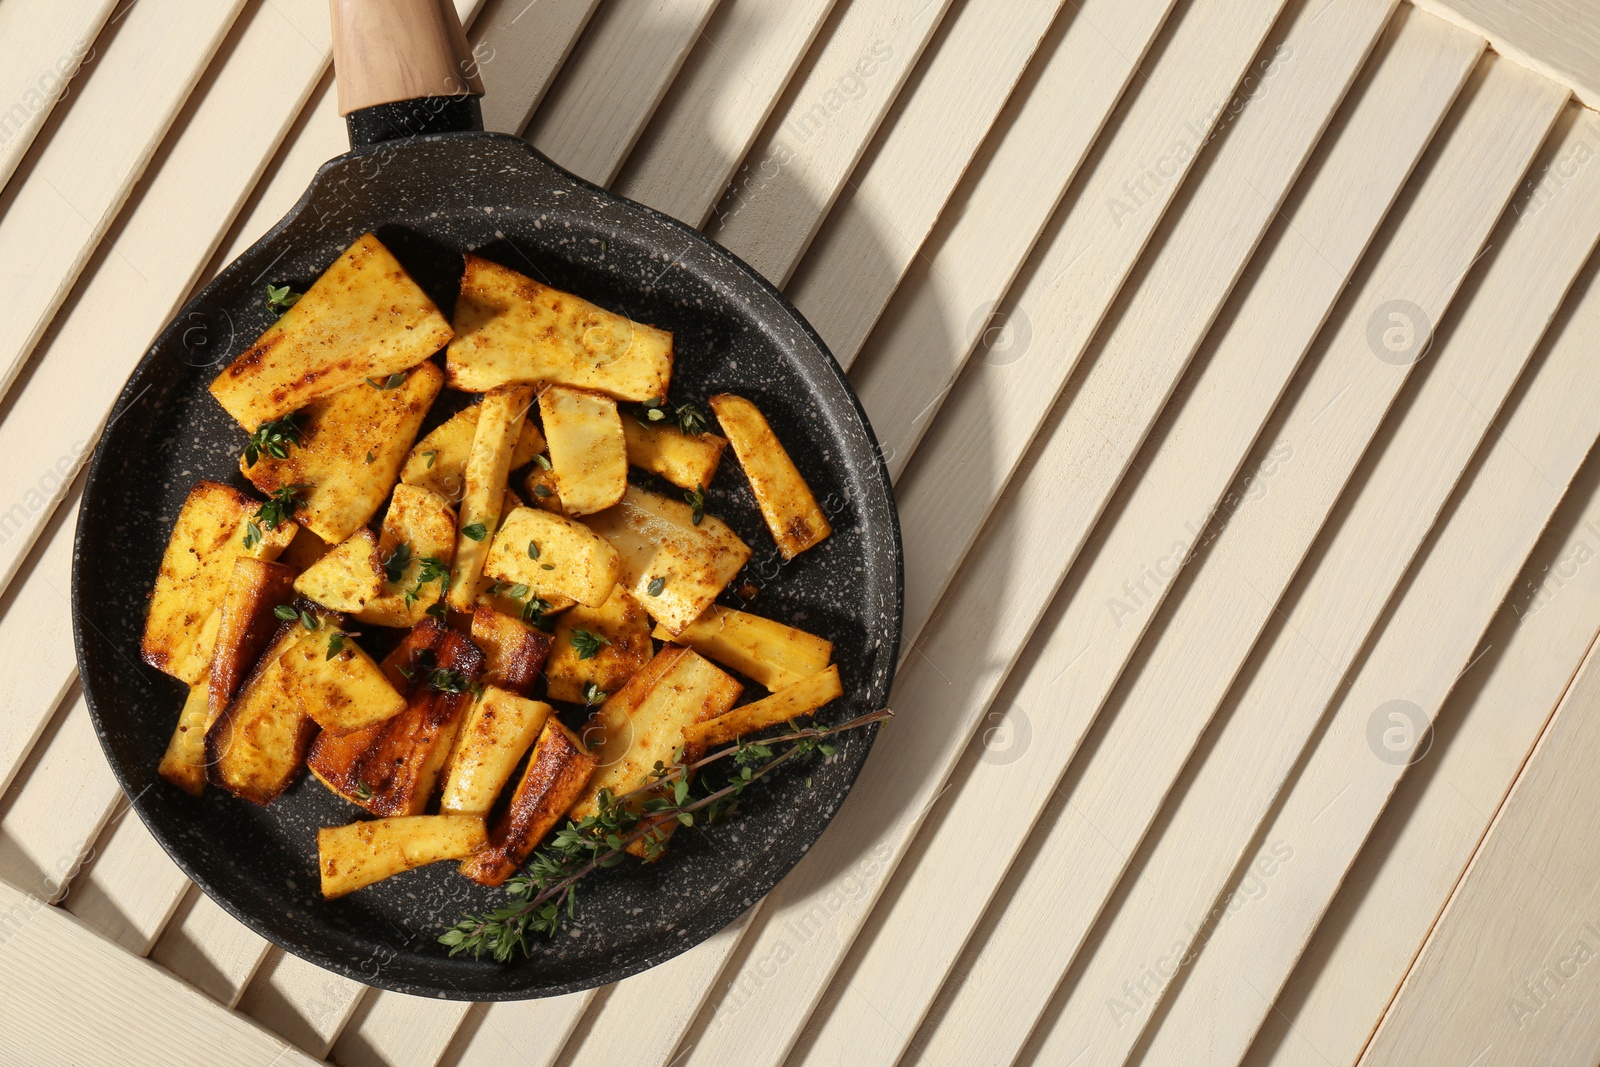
[461,715,595,886]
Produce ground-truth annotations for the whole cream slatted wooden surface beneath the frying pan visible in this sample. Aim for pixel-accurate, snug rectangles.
[0,0,1600,1067]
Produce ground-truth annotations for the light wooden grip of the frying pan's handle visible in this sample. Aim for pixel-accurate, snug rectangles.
[328,0,483,115]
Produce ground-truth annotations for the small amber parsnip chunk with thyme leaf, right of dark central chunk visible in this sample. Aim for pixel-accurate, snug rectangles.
[546,585,654,704]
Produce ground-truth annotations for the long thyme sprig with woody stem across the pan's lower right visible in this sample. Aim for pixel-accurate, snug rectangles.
[438,709,894,963]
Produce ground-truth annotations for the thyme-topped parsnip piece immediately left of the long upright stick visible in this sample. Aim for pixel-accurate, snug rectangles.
[355,485,456,627]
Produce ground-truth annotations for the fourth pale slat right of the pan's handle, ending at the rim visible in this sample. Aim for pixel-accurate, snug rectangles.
[706,0,950,286]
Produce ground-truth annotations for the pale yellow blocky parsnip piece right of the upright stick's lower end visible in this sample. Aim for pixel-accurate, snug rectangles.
[483,507,622,605]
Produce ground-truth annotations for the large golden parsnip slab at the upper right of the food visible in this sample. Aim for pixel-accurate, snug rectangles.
[446,254,672,400]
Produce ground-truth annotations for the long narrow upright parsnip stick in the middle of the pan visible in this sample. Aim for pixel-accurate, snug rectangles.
[446,386,533,611]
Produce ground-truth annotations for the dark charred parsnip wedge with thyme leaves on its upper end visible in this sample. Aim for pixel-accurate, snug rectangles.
[307,630,483,816]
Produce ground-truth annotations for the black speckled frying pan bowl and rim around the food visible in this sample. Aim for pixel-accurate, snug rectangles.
[74,133,906,1000]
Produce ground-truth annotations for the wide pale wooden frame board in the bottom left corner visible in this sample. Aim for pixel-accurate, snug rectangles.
[0,883,314,1067]
